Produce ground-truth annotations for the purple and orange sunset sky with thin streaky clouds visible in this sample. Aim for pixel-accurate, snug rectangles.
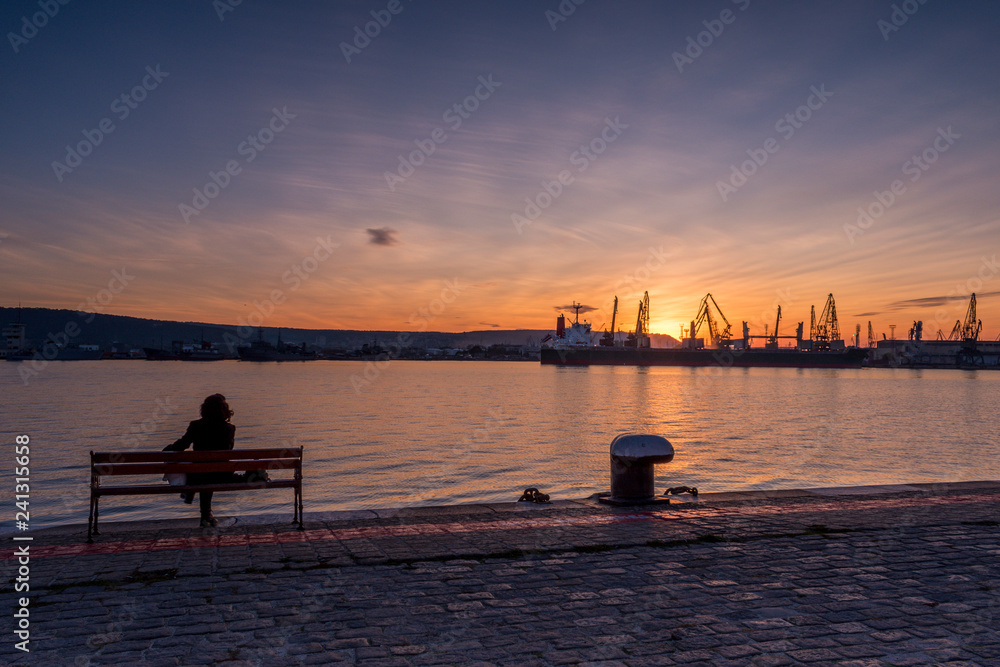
[0,0,1000,339]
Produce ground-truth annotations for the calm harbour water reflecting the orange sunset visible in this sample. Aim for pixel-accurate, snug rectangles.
[0,361,1000,531]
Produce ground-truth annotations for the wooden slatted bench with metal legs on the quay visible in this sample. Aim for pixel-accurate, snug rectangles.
[87,447,302,542]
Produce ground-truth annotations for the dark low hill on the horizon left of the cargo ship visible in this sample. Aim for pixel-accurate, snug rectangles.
[0,308,677,350]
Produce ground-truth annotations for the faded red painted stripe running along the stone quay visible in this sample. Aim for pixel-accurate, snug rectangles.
[9,494,1000,560]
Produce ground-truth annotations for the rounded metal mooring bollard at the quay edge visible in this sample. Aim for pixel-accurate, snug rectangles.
[607,433,674,505]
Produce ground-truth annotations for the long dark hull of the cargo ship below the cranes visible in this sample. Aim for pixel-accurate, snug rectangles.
[541,347,868,368]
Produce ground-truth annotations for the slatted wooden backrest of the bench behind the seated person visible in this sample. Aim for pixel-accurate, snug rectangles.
[90,447,302,477]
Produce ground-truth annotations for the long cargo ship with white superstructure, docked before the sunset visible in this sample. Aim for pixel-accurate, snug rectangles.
[541,293,868,368]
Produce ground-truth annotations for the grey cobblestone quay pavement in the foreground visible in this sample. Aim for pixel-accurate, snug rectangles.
[0,482,1000,666]
